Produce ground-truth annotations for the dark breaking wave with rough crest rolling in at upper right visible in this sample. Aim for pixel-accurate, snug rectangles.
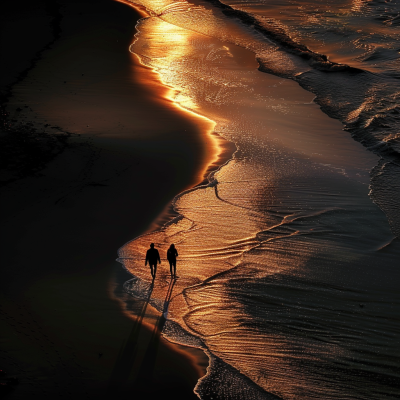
[194,0,400,162]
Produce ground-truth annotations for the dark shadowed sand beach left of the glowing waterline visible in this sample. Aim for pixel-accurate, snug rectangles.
[0,0,228,399]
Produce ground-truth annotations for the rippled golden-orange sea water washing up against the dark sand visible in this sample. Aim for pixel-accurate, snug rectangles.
[119,0,400,399]
